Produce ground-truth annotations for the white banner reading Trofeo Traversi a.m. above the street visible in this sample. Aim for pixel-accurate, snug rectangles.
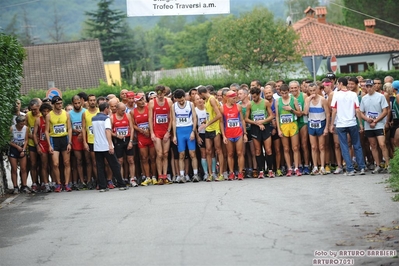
[126,0,230,17]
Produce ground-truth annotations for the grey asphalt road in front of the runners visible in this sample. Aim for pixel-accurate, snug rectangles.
[0,174,399,266]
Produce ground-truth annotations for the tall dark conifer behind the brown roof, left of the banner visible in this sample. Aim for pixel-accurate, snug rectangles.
[85,0,134,65]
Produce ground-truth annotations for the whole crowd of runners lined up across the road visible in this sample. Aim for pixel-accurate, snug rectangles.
[8,73,399,193]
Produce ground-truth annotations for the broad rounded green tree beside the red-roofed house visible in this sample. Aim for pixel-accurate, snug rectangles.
[208,8,303,71]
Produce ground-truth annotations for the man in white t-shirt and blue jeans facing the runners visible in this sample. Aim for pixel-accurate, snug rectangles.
[330,78,366,176]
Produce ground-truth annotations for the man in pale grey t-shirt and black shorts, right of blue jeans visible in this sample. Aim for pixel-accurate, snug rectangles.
[360,79,389,174]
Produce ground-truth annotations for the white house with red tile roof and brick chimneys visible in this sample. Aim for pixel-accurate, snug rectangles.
[293,7,399,75]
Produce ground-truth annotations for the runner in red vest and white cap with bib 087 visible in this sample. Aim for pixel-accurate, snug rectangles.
[220,91,248,181]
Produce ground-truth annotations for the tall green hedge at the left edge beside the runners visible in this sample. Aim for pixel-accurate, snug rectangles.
[0,34,25,195]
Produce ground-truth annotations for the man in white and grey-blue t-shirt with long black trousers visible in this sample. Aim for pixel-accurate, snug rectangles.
[92,102,127,192]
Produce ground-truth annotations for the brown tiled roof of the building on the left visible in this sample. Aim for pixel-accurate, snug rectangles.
[21,40,106,94]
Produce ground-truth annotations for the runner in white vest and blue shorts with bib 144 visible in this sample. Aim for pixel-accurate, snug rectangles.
[171,89,199,183]
